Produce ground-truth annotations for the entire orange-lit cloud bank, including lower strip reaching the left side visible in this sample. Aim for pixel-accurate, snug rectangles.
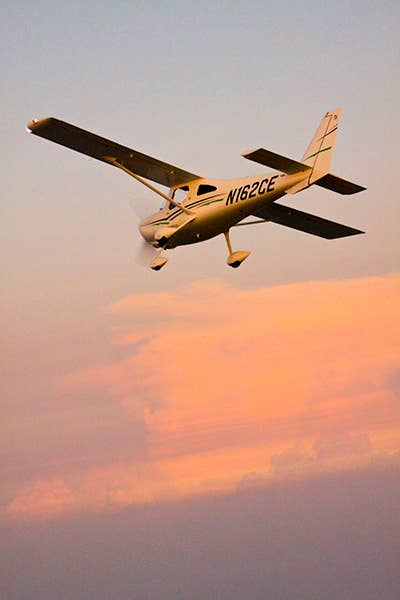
[8,275,400,516]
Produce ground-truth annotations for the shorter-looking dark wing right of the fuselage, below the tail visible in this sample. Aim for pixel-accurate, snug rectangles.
[254,203,364,240]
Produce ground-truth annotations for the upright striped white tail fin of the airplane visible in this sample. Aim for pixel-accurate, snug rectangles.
[301,108,341,185]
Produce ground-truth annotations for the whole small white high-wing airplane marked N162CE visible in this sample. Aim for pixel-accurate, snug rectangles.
[27,110,366,271]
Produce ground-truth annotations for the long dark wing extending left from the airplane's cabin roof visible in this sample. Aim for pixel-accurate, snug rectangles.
[27,117,200,187]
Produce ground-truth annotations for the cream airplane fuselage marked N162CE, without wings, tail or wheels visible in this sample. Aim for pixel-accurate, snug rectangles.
[139,173,304,248]
